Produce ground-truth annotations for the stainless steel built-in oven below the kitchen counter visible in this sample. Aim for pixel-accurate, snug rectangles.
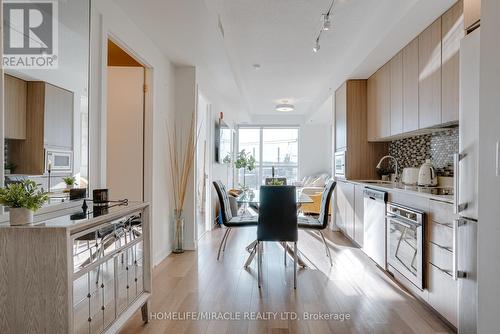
[386,203,425,290]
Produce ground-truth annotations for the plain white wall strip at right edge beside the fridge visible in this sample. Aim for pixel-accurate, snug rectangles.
[478,0,500,333]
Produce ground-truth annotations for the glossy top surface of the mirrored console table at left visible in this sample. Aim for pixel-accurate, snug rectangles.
[0,202,149,234]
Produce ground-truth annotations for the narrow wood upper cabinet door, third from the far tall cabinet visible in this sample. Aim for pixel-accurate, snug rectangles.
[389,52,403,136]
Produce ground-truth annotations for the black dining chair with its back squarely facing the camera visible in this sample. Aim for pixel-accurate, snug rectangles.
[256,186,298,289]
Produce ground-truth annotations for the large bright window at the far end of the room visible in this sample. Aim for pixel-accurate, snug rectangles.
[237,127,299,189]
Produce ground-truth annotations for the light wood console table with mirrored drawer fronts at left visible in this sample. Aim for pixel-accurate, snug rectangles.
[0,203,152,333]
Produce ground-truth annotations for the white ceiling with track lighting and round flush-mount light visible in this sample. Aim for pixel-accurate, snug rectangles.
[118,0,456,121]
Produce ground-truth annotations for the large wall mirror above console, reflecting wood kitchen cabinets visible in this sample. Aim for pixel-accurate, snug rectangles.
[2,0,90,209]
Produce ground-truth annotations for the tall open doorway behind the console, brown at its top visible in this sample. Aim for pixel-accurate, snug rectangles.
[106,39,146,201]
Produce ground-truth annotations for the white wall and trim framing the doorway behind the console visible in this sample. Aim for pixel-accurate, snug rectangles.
[89,0,175,264]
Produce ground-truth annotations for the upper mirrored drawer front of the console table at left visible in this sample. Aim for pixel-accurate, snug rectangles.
[72,213,142,273]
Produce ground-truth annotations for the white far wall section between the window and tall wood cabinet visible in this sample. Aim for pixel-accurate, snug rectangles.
[299,123,332,179]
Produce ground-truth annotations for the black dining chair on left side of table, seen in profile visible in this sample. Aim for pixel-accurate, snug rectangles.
[213,181,258,261]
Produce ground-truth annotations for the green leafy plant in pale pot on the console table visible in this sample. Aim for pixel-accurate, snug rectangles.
[0,180,48,226]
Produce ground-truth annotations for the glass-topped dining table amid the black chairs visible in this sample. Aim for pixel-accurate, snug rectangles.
[236,189,314,268]
